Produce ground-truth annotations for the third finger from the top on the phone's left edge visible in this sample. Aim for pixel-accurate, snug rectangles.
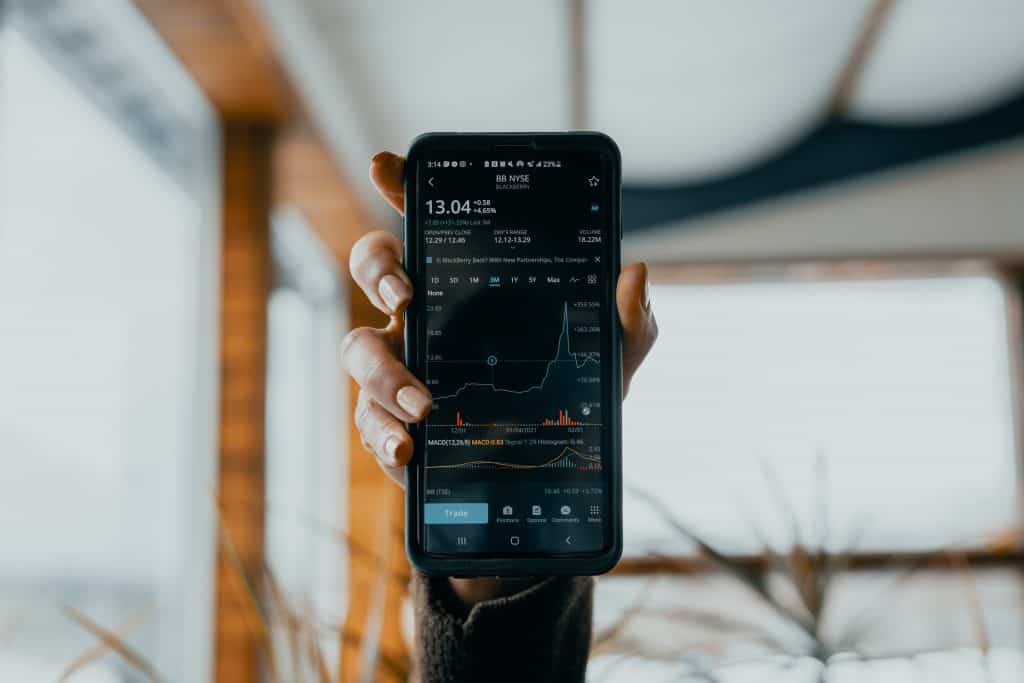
[341,328,432,422]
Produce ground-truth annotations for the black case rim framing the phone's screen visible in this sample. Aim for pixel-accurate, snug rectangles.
[402,132,623,578]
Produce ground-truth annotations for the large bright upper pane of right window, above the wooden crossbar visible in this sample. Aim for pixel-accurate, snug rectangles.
[624,275,1019,555]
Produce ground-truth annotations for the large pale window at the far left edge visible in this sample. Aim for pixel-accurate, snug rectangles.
[0,2,218,682]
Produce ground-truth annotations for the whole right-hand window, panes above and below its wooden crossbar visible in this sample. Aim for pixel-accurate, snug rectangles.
[591,266,1024,681]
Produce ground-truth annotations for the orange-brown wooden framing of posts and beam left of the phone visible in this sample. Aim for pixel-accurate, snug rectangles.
[135,0,409,683]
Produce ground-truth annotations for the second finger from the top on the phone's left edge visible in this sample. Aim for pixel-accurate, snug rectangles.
[348,230,413,315]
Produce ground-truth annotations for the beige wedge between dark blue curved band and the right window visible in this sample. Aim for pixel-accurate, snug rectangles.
[623,141,1024,264]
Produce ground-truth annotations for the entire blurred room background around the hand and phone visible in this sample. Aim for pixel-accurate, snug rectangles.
[0,0,1024,683]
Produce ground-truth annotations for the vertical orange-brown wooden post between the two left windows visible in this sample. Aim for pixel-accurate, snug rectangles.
[214,123,273,683]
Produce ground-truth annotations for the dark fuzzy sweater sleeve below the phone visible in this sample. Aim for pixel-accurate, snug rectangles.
[412,575,594,683]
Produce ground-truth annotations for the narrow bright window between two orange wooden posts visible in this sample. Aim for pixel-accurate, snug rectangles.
[265,209,347,675]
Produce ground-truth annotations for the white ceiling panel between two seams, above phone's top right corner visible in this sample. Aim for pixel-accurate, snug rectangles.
[588,0,870,182]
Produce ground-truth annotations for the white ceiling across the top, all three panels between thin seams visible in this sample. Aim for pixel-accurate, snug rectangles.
[263,0,1024,193]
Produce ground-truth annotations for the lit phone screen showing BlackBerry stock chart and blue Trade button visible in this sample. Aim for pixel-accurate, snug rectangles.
[417,149,617,553]
